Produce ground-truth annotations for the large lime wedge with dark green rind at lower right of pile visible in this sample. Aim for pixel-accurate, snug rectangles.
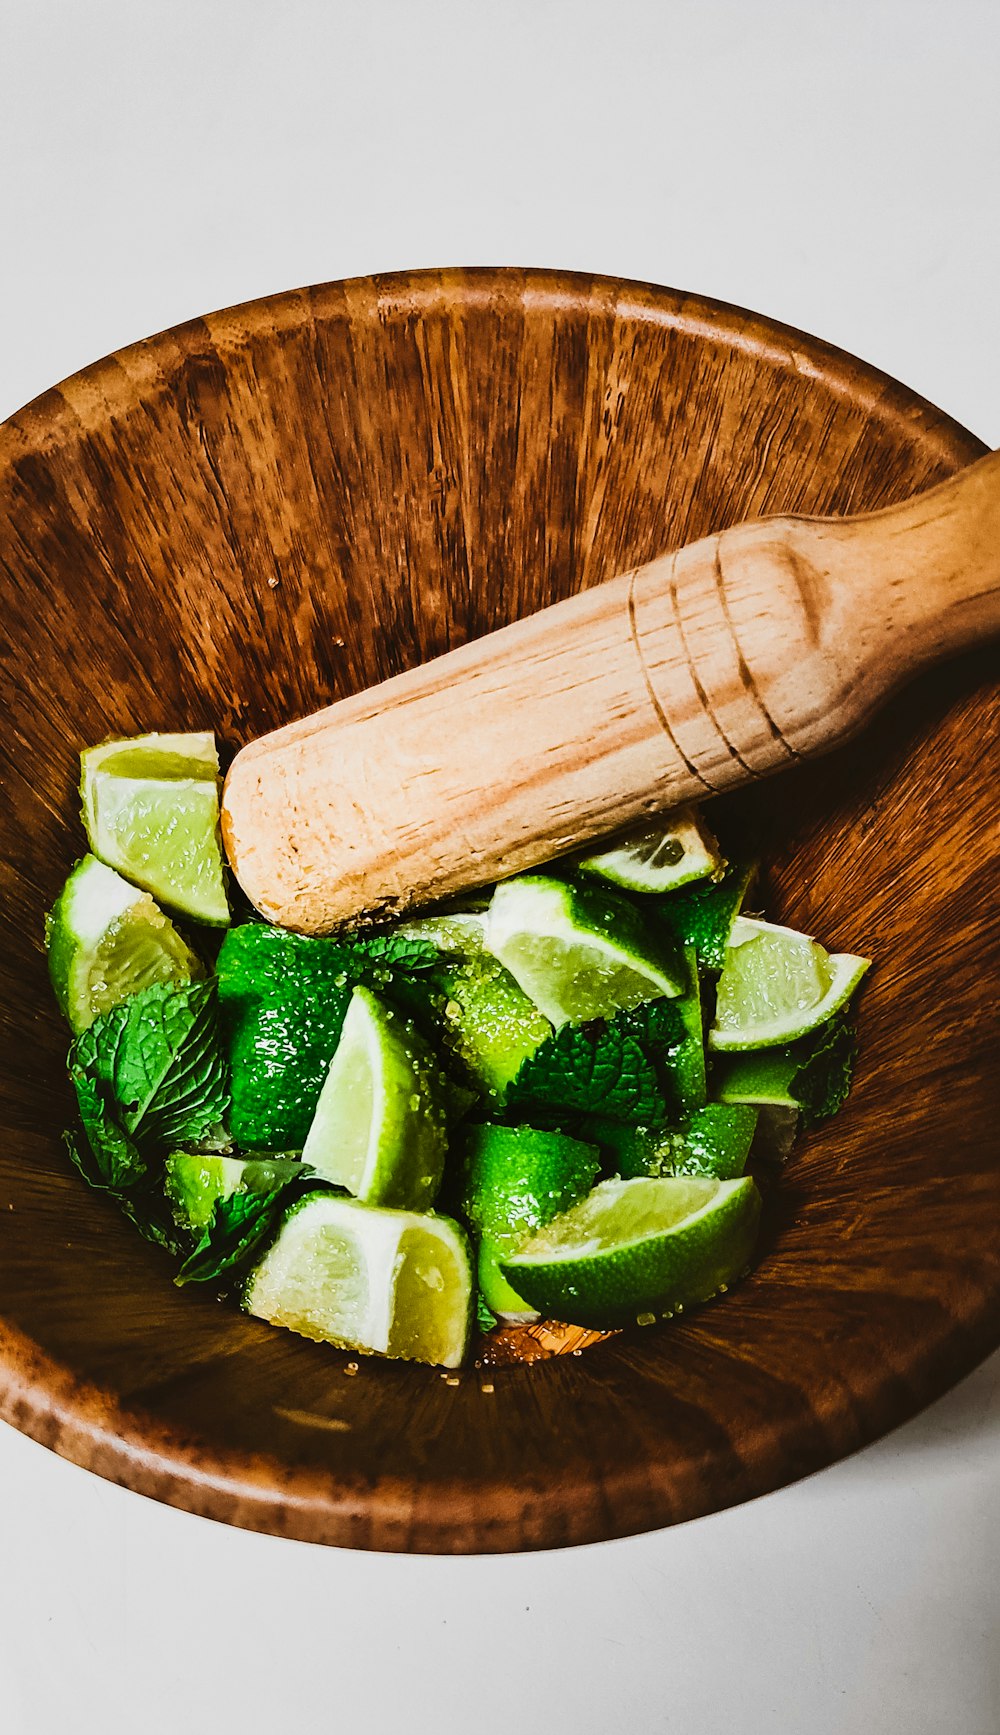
[503,1176,760,1329]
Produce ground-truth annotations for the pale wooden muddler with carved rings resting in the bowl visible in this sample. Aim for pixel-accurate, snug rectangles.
[222,453,1000,933]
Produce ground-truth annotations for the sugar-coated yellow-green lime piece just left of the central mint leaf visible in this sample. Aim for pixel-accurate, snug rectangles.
[441,953,552,1100]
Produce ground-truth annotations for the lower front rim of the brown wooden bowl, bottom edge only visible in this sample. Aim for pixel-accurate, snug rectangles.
[0,1310,1000,1555]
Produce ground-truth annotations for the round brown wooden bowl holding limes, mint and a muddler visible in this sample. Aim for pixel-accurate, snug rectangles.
[0,271,1000,1551]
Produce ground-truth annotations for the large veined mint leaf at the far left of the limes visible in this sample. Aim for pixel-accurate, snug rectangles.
[69,982,229,1147]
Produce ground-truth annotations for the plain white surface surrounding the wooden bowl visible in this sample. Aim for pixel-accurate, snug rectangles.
[0,0,1000,1735]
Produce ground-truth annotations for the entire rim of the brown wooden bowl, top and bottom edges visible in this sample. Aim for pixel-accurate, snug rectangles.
[0,265,1000,1553]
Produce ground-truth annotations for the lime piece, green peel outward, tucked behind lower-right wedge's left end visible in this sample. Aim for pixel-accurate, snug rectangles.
[462,1126,599,1320]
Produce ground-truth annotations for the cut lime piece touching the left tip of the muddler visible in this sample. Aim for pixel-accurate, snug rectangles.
[80,732,229,926]
